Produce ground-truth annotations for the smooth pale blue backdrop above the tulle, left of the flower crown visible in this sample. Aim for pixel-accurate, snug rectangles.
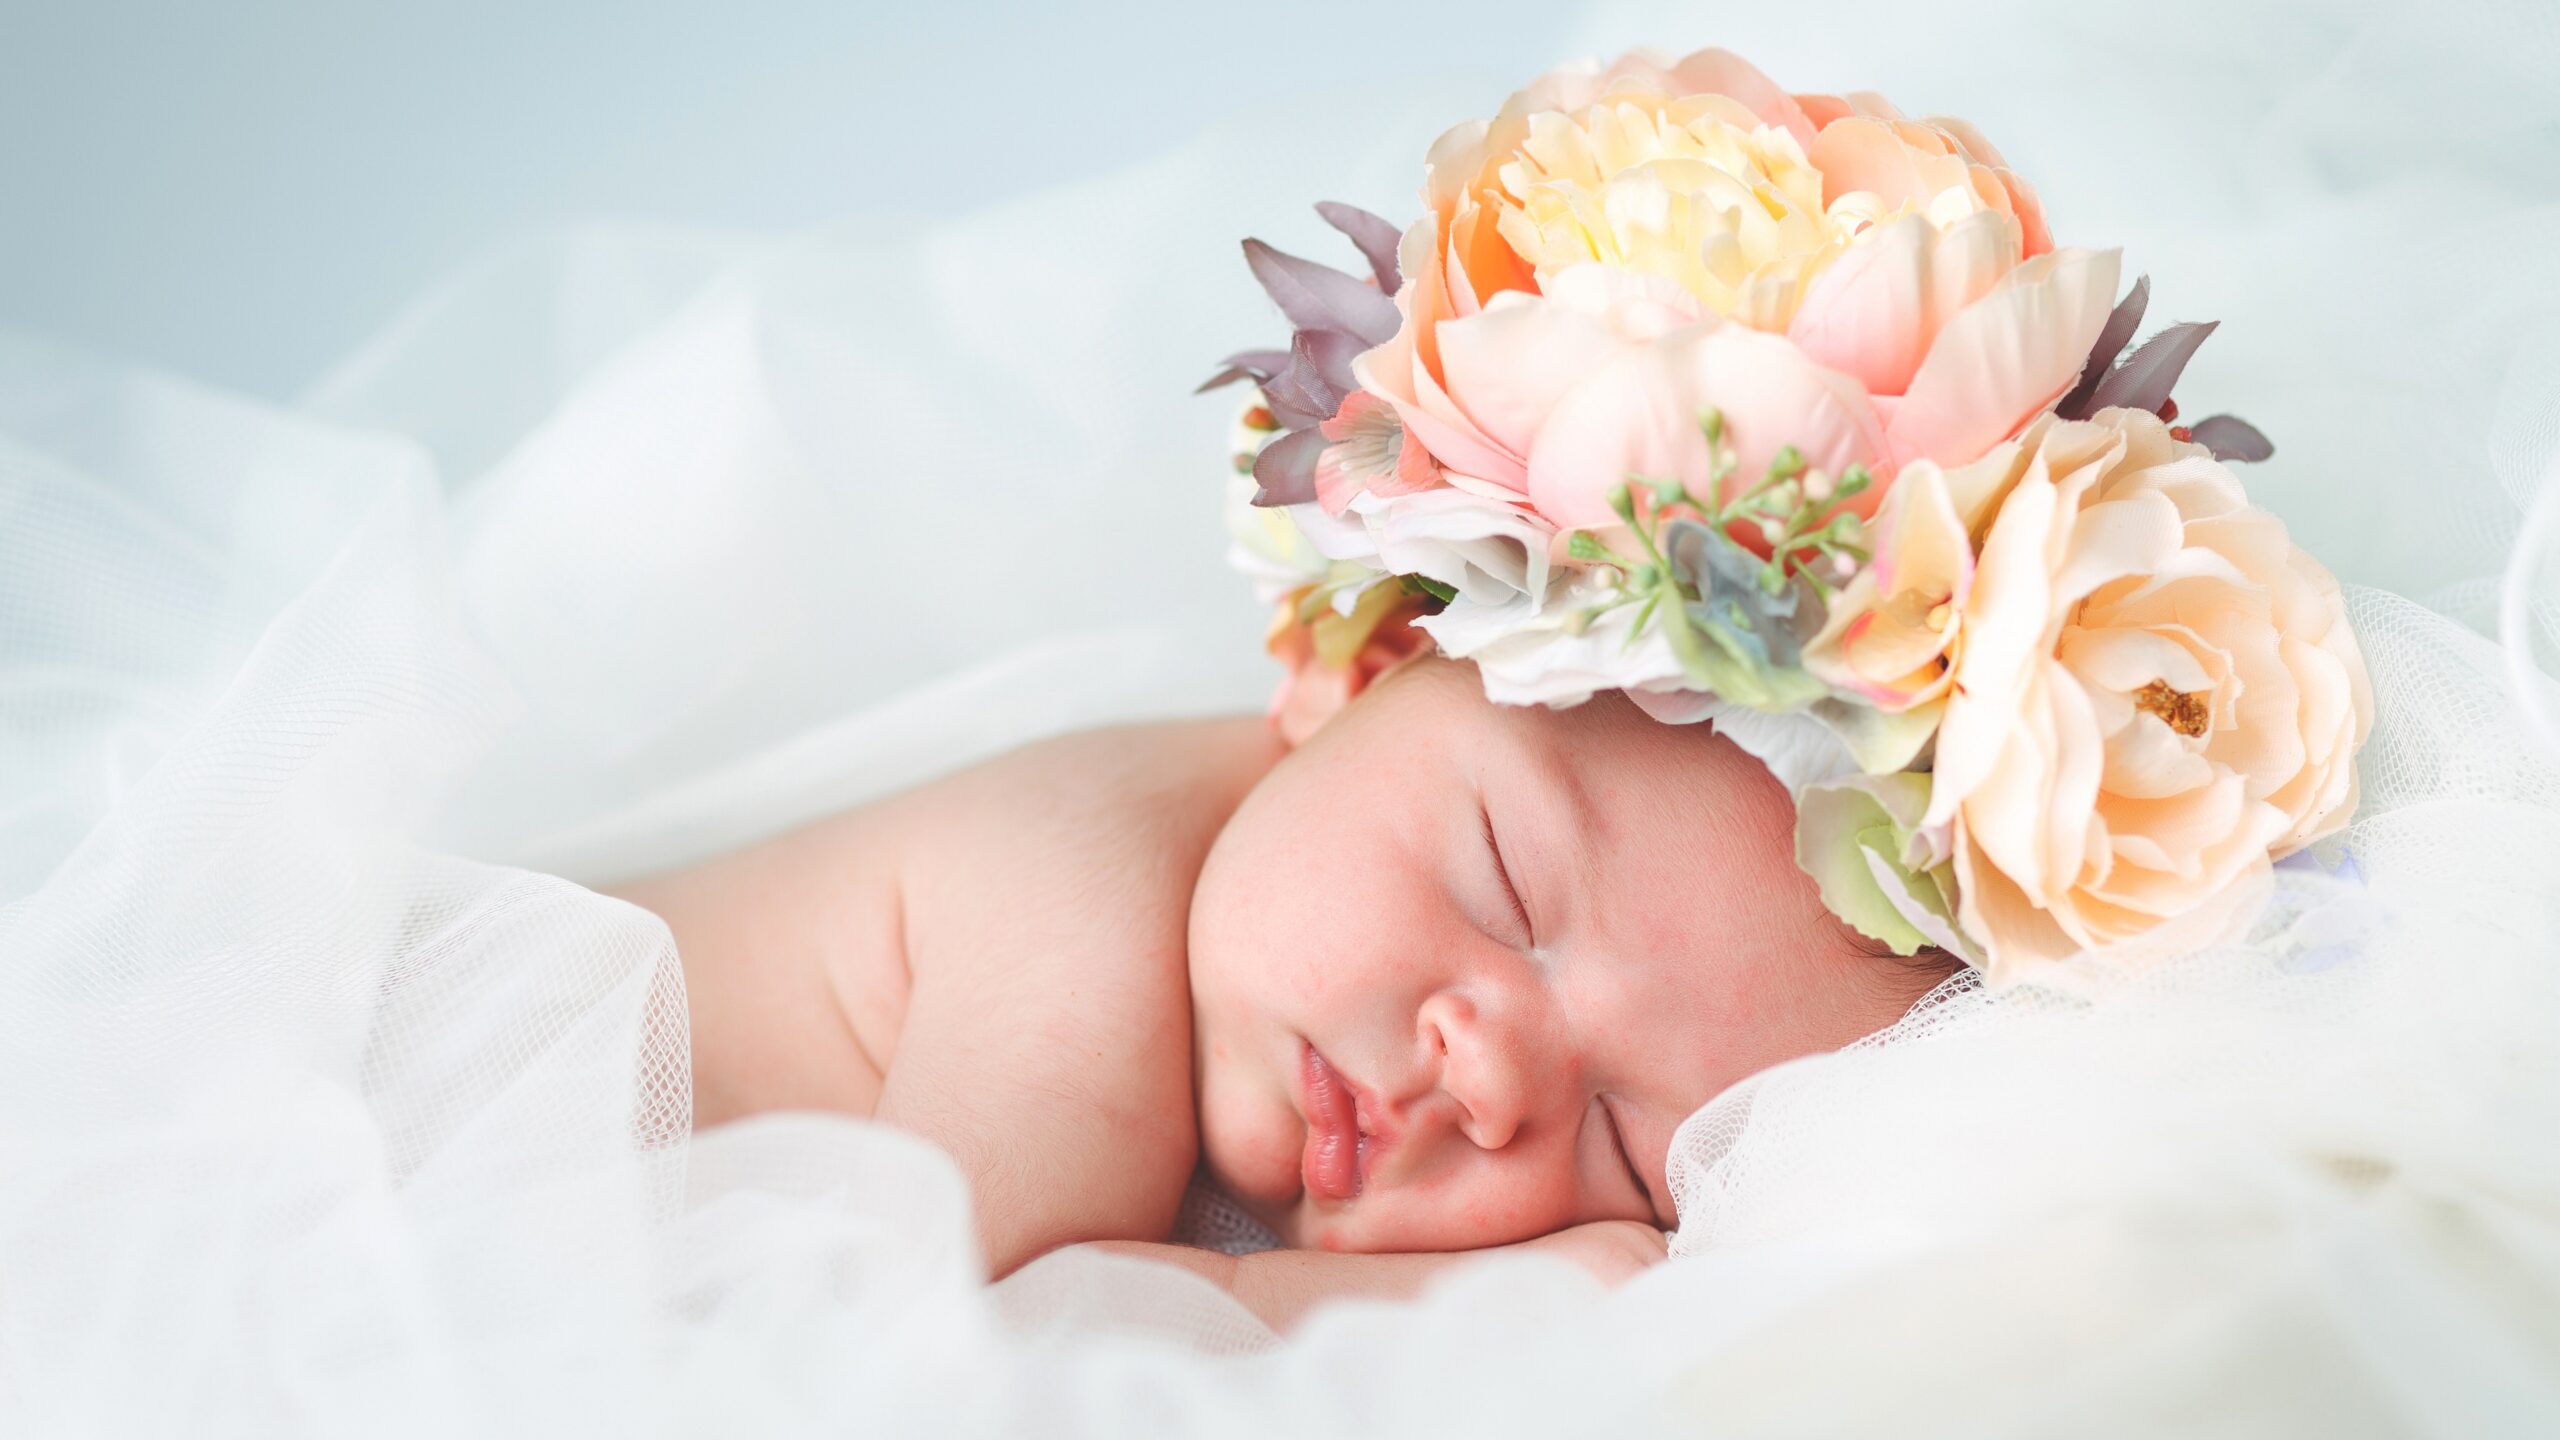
[0,0,1577,397]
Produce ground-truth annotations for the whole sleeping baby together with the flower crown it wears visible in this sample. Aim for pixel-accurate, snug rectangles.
[630,39,2373,1325]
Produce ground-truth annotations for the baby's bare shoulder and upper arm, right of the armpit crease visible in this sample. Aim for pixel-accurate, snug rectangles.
[878,720,1272,1273]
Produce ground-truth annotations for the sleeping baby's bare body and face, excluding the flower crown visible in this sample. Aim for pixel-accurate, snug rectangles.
[622,659,1956,1327]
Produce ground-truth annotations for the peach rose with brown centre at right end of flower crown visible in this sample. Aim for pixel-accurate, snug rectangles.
[1923,410,2373,979]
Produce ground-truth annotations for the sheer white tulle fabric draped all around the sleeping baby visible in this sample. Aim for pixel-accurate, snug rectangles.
[0,5,2560,1437]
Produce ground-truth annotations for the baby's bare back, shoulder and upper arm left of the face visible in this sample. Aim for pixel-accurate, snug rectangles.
[601,720,1277,1276]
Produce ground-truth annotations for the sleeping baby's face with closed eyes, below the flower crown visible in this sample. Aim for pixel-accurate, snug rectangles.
[1190,661,1933,1250]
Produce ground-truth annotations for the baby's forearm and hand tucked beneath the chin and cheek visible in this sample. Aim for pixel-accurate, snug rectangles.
[1070,1220,1667,1330]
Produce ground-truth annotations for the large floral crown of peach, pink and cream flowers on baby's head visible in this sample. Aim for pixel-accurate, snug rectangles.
[1203,49,2371,979]
